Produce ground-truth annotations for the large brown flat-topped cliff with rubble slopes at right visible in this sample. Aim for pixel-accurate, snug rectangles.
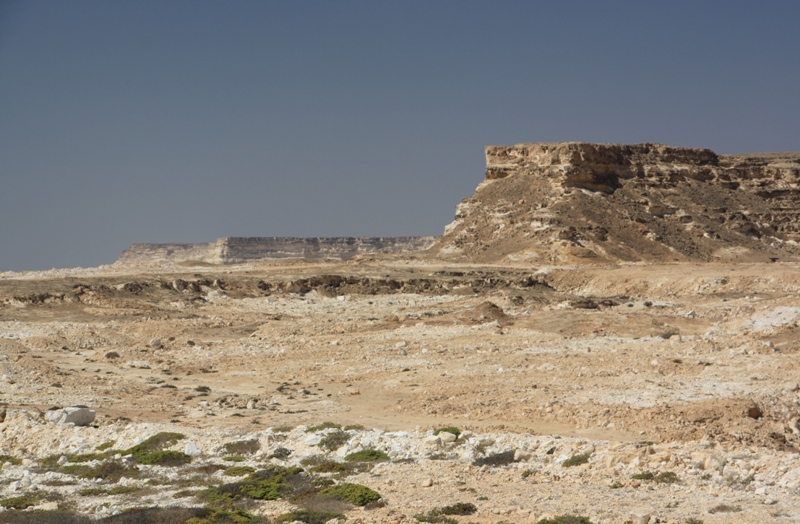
[432,142,800,263]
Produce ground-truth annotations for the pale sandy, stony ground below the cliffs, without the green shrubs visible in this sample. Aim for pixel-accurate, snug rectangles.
[0,256,800,523]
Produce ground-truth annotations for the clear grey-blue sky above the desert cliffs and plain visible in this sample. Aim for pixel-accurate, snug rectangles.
[0,0,800,271]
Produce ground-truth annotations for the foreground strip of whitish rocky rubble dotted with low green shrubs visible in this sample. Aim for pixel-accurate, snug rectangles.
[0,410,800,523]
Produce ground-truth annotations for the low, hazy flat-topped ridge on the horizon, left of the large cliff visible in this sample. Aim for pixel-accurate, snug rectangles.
[117,237,436,264]
